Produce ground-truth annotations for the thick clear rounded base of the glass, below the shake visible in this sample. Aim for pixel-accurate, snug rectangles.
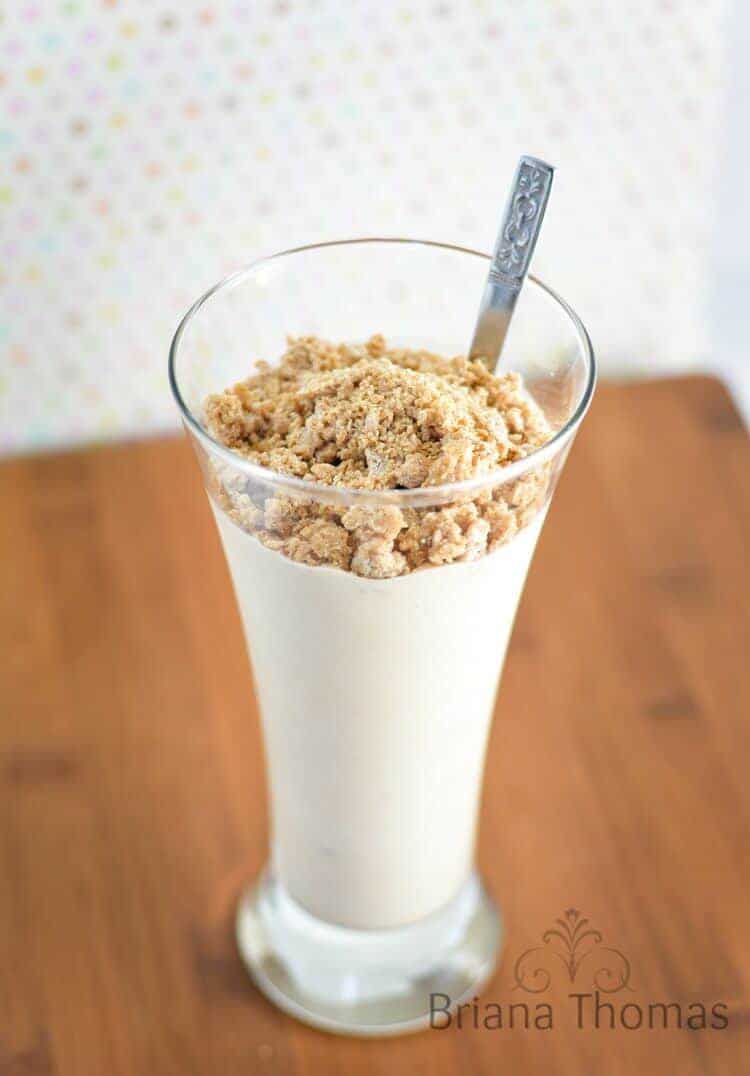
[237,874,503,1035]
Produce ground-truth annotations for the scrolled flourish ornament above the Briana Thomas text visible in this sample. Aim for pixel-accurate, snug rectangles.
[513,908,633,994]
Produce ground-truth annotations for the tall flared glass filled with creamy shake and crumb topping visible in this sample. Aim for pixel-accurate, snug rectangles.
[166,240,593,1034]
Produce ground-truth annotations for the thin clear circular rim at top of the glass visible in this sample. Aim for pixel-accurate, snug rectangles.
[169,236,596,507]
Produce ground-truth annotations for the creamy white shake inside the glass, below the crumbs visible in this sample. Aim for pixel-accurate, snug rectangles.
[212,504,544,929]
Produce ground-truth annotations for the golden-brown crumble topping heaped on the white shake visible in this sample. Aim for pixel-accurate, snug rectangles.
[206,336,552,579]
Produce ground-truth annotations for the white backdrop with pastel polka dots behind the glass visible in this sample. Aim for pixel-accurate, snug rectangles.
[0,0,724,452]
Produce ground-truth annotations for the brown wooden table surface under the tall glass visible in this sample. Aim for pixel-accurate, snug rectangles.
[0,379,750,1076]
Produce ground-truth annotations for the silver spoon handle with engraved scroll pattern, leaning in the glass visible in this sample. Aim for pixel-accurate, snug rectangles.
[469,157,554,371]
